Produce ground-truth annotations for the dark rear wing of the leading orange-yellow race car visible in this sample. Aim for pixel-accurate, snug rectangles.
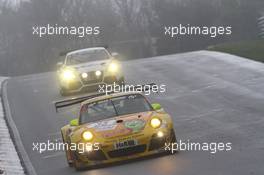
[54,83,156,112]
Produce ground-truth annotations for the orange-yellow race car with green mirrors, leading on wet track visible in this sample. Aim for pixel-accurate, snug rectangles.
[57,89,176,170]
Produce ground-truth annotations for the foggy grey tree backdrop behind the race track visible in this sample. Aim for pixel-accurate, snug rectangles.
[0,0,264,76]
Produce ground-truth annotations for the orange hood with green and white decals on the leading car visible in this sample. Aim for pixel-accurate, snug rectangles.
[84,111,155,139]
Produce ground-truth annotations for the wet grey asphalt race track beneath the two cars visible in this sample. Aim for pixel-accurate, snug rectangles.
[3,51,264,175]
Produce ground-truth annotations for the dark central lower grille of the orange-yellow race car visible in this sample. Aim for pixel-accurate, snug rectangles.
[108,145,146,158]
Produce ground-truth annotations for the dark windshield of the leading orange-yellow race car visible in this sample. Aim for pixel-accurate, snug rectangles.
[80,94,153,124]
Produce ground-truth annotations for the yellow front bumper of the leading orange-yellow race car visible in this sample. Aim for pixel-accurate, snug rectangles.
[74,129,174,166]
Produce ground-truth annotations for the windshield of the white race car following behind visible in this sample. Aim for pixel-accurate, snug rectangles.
[66,49,109,65]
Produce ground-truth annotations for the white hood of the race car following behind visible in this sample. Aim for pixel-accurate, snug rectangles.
[71,60,111,72]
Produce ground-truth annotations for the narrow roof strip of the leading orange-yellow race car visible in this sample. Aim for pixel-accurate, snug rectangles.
[81,92,145,106]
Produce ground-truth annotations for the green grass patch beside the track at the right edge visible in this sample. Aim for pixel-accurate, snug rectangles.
[207,39,264,62]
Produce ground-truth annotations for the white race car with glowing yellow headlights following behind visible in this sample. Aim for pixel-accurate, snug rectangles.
[57,47,124,95]
